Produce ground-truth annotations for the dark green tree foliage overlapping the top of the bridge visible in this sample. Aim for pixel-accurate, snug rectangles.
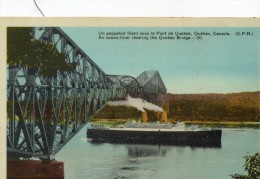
[7,27,76,77]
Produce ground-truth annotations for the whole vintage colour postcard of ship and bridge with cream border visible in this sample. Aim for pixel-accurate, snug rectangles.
[0,18,260,179]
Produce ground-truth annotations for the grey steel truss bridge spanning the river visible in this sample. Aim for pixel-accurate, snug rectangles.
[7,27,166,160]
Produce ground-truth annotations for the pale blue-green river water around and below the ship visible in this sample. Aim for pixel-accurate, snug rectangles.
[56,128,260,179]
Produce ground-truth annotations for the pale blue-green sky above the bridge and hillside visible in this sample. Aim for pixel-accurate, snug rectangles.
[62,27,260,94]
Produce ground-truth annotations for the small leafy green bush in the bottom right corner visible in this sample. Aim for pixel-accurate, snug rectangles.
[232,153,260,179]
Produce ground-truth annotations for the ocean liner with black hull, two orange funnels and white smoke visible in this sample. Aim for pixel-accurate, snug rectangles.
[87,98,222,147]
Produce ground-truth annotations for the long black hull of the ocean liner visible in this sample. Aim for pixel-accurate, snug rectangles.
[87,129,222,148]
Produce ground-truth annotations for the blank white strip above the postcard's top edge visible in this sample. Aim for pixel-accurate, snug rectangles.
[0,0,260,17]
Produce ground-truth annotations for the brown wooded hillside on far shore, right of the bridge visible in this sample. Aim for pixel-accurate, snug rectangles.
[159,91,260,121]
